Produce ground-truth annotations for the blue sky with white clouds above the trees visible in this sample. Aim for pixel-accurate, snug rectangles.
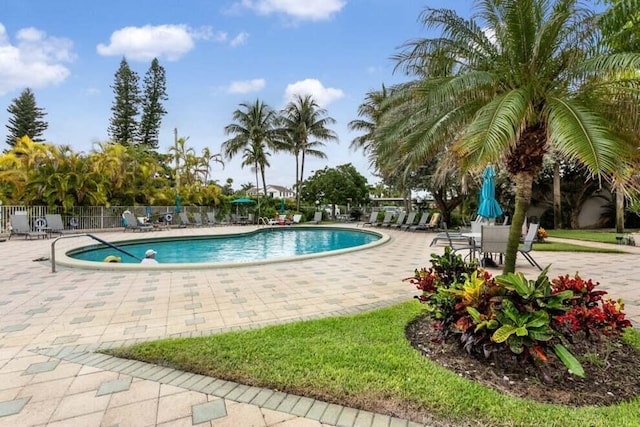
[0,0,464,189]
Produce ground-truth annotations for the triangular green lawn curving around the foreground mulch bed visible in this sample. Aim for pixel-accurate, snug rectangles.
[108,301,640,426]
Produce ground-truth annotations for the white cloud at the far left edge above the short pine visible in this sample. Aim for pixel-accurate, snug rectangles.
[0,24,75,95]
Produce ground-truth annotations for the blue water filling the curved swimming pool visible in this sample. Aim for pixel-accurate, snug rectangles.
[67,227,380,263]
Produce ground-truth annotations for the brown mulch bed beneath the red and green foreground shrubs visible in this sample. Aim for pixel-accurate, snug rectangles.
[406,316,640,406]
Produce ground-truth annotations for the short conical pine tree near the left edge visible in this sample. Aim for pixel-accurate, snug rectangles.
[6,88,49,147]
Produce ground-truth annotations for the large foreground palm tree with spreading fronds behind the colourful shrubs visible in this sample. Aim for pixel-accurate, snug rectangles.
[383,0,640,272]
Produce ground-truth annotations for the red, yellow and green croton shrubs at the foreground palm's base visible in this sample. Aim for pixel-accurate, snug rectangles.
[405,252,631,376]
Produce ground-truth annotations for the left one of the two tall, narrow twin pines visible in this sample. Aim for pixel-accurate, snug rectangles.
[109,58,140,145]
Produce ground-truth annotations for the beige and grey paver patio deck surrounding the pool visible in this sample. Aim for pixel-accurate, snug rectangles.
[0,227,640,427]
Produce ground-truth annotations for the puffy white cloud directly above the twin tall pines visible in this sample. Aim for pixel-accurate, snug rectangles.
[96,24,222,61]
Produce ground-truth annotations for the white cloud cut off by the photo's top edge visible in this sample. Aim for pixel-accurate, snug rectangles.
[240,0,346,21]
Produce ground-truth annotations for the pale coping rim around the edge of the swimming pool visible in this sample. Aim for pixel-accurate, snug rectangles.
[51,224,391,271]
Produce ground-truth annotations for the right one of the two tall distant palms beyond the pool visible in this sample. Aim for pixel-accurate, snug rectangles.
[281,95,338,211]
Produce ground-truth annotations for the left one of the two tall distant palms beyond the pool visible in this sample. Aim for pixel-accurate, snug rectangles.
[222,99,279,195]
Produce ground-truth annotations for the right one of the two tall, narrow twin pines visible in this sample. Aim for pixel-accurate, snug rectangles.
[139,58,169,149]
